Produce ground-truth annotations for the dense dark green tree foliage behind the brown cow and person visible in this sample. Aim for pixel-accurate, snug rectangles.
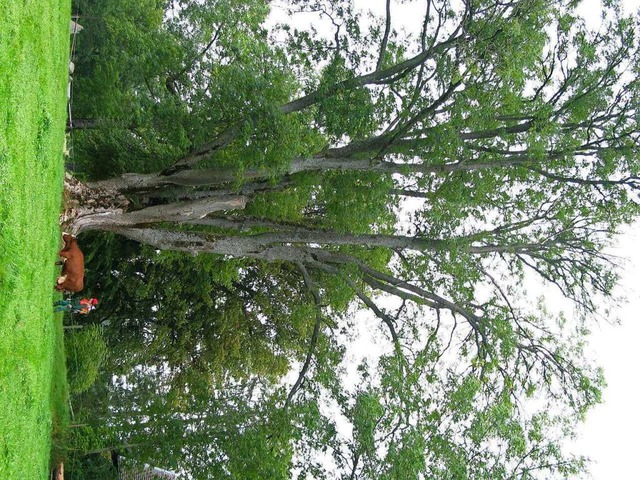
[81,235,313,389]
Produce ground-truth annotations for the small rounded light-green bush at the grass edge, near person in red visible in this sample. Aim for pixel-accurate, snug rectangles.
[65,325,107,394]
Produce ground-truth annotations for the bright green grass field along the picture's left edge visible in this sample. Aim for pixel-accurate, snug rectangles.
[0,0,70,480]
